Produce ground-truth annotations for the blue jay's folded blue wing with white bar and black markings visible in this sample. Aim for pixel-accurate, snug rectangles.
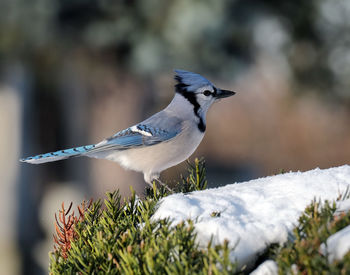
[88,123,180,154]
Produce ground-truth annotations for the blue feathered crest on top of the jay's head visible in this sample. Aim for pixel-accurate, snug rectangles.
[175,70,214,91]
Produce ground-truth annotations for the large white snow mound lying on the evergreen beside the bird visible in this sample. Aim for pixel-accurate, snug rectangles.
[153,165,350,265]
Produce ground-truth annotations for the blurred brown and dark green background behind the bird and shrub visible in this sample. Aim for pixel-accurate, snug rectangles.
[0,0,350,274]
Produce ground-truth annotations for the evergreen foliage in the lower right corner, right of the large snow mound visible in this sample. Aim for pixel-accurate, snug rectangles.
[273,192,350,274]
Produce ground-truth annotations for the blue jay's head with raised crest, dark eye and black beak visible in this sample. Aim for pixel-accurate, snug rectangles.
[175,70,235,114]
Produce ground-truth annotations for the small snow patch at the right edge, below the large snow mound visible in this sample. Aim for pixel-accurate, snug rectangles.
[321,225,350,263]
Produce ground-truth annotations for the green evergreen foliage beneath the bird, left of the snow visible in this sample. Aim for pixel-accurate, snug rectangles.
[50,159,236,274]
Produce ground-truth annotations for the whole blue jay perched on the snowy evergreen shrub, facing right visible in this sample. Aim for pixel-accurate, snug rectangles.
[21,70,235,189]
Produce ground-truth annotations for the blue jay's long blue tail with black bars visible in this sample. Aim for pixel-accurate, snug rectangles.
[20,145,95,164]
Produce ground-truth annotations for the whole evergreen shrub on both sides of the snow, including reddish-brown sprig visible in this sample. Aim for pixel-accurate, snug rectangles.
[50,159,350,274]
